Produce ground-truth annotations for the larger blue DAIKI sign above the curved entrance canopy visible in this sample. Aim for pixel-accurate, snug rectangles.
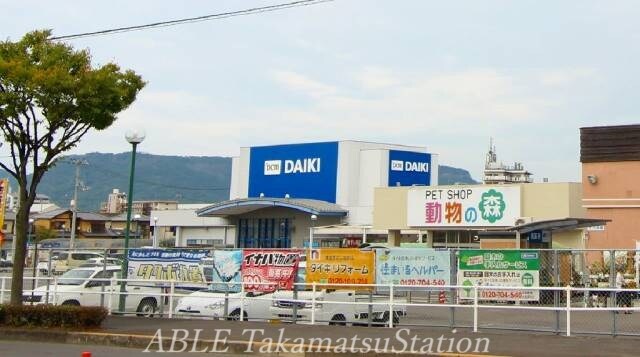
[249,142,338,203]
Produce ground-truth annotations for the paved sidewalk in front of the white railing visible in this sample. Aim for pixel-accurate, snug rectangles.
[0,316,640,357]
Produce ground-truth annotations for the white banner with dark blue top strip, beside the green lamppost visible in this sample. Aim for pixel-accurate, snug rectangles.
[127,249,207,288]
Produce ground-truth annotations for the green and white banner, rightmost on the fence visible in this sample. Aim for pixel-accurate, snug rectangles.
[458,250,540,301]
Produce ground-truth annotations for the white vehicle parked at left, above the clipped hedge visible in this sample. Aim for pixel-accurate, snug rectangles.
[22,265,162,317]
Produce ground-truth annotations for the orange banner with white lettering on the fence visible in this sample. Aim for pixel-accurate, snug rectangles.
[307,248,375,289]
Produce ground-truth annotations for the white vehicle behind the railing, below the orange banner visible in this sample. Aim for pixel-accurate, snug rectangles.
[270,289,406,325]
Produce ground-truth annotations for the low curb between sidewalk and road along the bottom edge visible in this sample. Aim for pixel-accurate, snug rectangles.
[0,329,499,357]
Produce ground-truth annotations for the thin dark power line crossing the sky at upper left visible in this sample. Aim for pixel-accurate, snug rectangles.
[51,0,334,40]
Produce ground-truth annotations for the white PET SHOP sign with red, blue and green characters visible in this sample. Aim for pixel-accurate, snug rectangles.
[407,185,521,227]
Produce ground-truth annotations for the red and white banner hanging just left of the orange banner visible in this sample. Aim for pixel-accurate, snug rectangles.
[241,249,301,292]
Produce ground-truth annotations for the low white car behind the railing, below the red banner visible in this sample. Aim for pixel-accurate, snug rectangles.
[175,290,273,321]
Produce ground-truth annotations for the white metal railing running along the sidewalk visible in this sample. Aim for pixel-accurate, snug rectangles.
[0,276,640,336]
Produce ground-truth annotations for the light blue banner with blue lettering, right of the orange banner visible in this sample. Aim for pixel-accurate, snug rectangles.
[376,248,451,291]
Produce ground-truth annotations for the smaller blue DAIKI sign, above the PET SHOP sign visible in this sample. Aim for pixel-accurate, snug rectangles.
[389,150,431,187]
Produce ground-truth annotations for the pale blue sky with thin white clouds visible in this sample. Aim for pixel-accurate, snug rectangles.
[0,0,640,182]
